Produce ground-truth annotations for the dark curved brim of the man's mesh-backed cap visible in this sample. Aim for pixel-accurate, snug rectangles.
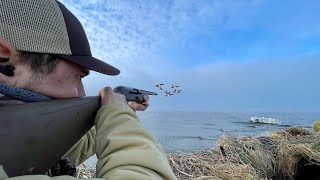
[57,54,120,76]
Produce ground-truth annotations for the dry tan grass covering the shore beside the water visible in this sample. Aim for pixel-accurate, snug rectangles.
[78,128,320,180]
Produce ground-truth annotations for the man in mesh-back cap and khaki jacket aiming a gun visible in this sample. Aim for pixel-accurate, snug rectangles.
[0,0,175,180]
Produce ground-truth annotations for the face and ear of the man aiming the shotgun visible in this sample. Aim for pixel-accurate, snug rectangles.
[0,37,89,98]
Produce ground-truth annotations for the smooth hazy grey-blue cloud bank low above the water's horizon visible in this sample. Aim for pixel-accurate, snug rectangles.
[154,55,320,112]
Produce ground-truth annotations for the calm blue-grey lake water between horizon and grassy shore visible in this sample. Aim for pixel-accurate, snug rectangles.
[85,111,320,167]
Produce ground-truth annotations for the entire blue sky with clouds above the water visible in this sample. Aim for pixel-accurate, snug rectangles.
[61,0,320,112]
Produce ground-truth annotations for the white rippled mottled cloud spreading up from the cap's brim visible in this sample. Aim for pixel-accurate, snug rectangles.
[58,0,264,95]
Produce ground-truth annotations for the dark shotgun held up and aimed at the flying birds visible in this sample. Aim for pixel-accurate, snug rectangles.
[0,86,157,177]
